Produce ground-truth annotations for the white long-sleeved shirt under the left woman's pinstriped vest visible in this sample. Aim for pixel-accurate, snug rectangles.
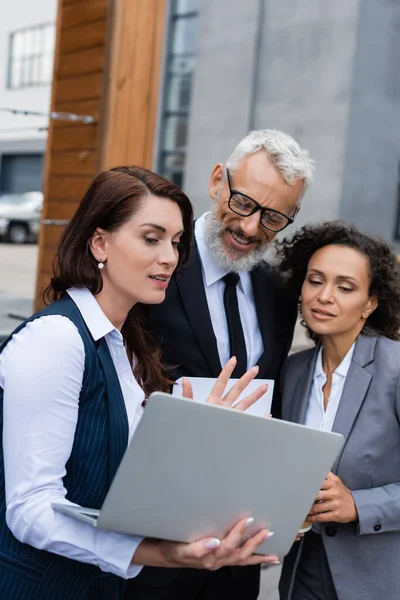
[0,289,144,579]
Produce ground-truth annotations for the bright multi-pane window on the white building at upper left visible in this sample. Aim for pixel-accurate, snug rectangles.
[8,23,55,88]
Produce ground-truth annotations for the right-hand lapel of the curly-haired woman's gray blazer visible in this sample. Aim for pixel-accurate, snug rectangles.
[332,335,377,471]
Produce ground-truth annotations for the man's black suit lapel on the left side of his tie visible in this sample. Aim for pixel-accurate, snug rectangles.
[176,243,221,377]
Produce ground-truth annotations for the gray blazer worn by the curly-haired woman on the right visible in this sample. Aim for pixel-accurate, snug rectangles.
[279,335,400,600]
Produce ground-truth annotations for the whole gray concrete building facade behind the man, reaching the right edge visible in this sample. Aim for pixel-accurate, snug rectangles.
[162,0,400,248]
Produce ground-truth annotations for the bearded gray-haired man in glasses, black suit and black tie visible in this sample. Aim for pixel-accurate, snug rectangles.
[126,129,314,600]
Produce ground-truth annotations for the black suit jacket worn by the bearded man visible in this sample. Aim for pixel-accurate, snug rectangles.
[148,244,297,416]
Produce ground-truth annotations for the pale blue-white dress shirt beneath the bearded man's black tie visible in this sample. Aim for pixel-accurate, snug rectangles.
[195,213,264,369]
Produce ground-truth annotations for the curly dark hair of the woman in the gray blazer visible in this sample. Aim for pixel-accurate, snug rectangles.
[276,221,400,342]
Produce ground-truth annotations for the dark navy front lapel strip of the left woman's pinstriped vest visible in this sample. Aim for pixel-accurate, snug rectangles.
[97,338,129,483]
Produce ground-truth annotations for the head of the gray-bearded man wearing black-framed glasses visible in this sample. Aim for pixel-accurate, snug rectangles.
[206,129,313,273]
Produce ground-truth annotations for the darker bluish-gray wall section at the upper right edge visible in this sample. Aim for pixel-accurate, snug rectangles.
[340,0,400,244]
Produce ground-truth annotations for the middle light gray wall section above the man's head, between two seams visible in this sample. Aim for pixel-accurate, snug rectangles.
[254,0,360,224]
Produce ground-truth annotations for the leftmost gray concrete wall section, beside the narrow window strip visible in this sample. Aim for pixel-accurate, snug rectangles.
[184,0,259,215]
